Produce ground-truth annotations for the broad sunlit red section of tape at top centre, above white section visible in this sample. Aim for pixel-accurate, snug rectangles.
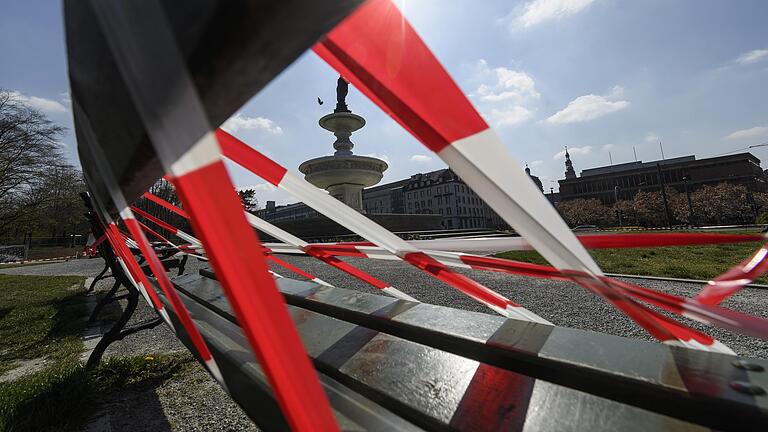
[313,0,488,152]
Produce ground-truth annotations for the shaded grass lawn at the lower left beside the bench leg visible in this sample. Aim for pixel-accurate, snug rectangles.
[0,275,193,431]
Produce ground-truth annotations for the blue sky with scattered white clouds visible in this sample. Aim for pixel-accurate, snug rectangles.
[0,0,768,203]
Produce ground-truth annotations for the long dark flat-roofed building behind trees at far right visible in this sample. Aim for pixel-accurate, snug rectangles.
[558,152,768,205]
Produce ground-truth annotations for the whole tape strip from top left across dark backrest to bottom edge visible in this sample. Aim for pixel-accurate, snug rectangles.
[93,2,339,431]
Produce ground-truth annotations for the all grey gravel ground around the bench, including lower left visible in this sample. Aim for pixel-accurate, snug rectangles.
[0,256,768,431]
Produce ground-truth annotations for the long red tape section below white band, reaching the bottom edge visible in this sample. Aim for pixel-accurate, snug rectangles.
[173,161,338,431]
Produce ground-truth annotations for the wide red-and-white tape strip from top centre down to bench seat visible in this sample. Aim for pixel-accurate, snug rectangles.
[310,0,736,352]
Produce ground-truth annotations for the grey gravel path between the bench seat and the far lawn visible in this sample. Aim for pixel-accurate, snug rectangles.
[272,256,768,359]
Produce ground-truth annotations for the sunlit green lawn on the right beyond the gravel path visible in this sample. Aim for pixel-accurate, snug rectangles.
[497,238,768,283]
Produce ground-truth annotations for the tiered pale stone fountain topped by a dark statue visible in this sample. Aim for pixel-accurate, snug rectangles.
[299,77,389,212]
